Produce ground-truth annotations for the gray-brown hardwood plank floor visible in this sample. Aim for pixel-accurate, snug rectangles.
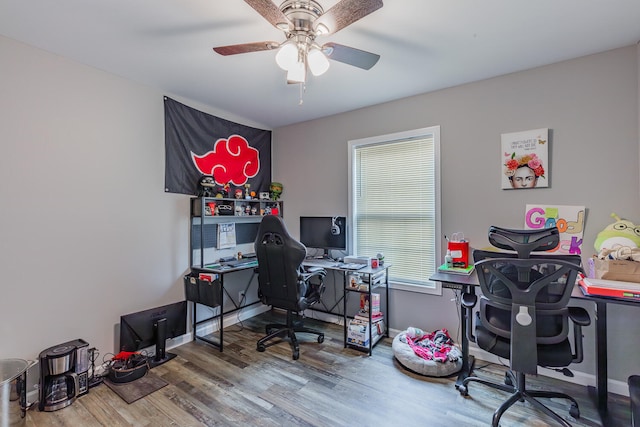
[26,312,631,427]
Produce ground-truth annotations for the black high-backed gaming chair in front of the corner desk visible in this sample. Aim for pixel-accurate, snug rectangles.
[255,215,327,360]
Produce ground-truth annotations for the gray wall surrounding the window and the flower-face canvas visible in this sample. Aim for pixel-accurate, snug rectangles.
[273,46,640,381]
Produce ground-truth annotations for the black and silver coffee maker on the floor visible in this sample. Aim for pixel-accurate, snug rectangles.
[38,339,89,411]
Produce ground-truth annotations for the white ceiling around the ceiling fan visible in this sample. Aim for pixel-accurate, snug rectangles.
[0,0,640,128]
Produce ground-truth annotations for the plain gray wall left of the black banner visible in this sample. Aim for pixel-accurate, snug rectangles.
[0,37,262,360]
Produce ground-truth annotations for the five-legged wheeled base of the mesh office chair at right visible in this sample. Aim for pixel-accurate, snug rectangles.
[458,371,580,427]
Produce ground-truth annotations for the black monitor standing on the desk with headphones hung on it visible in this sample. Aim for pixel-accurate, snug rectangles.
[300,216,347,258]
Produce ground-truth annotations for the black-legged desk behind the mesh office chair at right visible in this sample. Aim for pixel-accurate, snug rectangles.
[429,271,640,425]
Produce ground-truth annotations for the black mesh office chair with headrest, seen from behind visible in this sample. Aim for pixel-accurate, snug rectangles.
[458,227,590,426]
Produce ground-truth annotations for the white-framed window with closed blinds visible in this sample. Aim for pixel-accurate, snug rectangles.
[349,126,441,294]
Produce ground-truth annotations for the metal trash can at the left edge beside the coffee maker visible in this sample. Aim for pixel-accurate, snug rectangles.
[0,359,29,427]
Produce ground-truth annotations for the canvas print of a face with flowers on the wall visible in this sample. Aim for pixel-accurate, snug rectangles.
[501,128,549,190]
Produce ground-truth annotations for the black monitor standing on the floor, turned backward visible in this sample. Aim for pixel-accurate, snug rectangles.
[120,301,187,367]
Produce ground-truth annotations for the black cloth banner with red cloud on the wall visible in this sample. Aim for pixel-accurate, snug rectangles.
[164,96,271,195]
